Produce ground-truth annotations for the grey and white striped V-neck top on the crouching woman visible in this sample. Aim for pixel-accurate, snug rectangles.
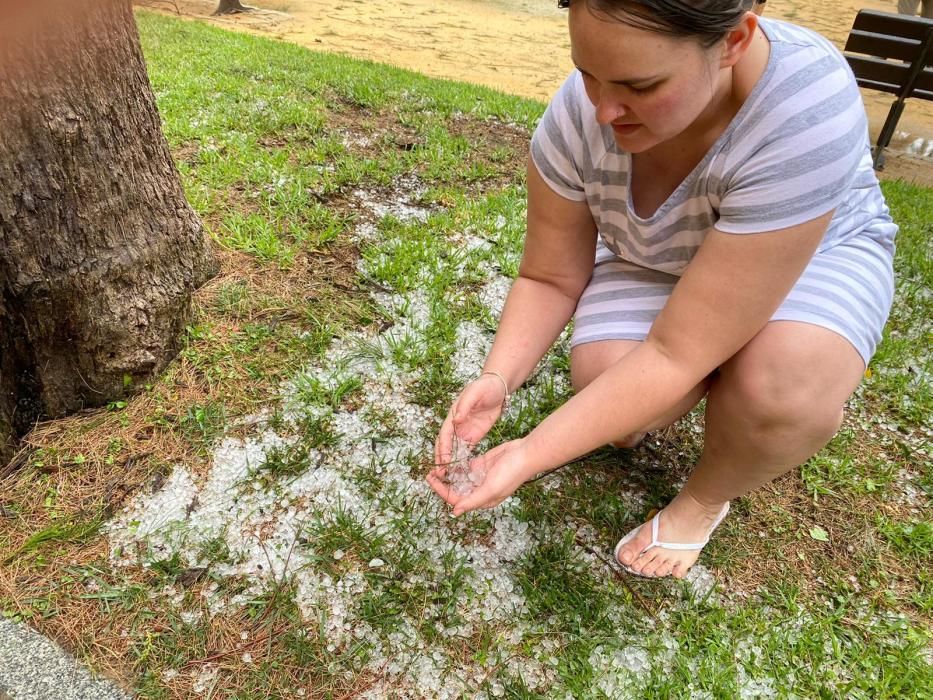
[531,18,897,275]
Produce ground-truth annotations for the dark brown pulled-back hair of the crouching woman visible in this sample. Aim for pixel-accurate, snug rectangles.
[557,0,752,48]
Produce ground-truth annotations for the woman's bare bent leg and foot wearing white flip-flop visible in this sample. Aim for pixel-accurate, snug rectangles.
[619,321,865,578]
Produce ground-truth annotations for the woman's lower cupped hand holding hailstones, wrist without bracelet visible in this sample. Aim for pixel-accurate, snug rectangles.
[427,439,534,516]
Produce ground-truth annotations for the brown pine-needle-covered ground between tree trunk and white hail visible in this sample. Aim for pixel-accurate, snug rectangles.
[0,130,365,684]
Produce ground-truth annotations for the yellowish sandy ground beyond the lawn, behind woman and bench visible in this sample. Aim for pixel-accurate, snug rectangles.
[138,0,933,187]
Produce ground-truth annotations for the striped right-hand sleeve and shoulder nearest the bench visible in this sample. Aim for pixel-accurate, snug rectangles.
[715,50,873,233]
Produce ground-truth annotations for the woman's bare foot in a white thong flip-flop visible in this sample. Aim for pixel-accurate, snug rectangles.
[618,491,726,578]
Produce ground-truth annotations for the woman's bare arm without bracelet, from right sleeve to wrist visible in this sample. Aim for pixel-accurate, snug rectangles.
[524,213,832,478]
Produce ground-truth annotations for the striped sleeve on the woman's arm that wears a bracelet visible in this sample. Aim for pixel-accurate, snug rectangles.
[531,71,586,202]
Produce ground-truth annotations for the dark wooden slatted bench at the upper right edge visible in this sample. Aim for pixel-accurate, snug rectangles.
[845,10,933,170]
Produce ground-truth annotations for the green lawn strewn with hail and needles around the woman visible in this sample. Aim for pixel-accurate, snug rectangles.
[0,12,933,699]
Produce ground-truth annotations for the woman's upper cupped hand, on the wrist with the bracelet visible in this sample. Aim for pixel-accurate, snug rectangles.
[434,374,505,465]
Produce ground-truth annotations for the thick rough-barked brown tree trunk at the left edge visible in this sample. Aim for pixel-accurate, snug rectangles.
[0,0,216,458]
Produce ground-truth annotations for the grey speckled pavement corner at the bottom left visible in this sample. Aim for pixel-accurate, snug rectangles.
[0,619,131,700]
